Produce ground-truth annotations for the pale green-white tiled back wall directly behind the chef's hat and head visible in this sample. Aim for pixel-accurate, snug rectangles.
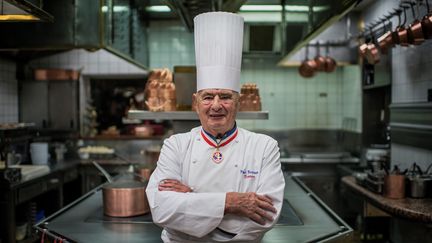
[149,21,361,132]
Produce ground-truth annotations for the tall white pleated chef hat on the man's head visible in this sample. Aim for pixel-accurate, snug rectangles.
[194,12,243,92]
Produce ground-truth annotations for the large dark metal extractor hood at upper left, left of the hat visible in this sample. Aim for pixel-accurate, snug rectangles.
[0,0,148,69]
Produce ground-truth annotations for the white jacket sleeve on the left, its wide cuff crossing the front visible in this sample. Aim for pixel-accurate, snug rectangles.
[146,137,225,237]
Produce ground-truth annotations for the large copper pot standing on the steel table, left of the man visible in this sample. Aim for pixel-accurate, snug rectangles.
[102,181,150,217]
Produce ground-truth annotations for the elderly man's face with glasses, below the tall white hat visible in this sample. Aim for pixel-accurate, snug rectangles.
[193,89,239,136]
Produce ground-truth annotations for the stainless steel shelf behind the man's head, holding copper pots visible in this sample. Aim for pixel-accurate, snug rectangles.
[128,110,268,121]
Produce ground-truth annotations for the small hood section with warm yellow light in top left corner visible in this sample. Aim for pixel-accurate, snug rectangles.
[0,0,54,22]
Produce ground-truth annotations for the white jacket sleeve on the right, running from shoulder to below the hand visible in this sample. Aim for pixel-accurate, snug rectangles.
[228,139,285,241]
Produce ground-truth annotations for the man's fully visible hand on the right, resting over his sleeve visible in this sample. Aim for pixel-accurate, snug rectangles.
[225,192,276,225]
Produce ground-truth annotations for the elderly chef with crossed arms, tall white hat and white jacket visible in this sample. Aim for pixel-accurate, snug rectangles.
[147,12,285,242]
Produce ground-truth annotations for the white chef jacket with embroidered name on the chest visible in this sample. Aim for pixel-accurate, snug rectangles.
[146,127,285,242]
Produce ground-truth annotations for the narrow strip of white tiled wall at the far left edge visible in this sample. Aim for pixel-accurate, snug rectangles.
[0,58,18,123]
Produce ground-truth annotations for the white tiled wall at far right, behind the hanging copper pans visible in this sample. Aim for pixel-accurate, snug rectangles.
[364,1,432,169]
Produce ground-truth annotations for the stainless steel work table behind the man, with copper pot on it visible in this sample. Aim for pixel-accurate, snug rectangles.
[36,175,352,243]
